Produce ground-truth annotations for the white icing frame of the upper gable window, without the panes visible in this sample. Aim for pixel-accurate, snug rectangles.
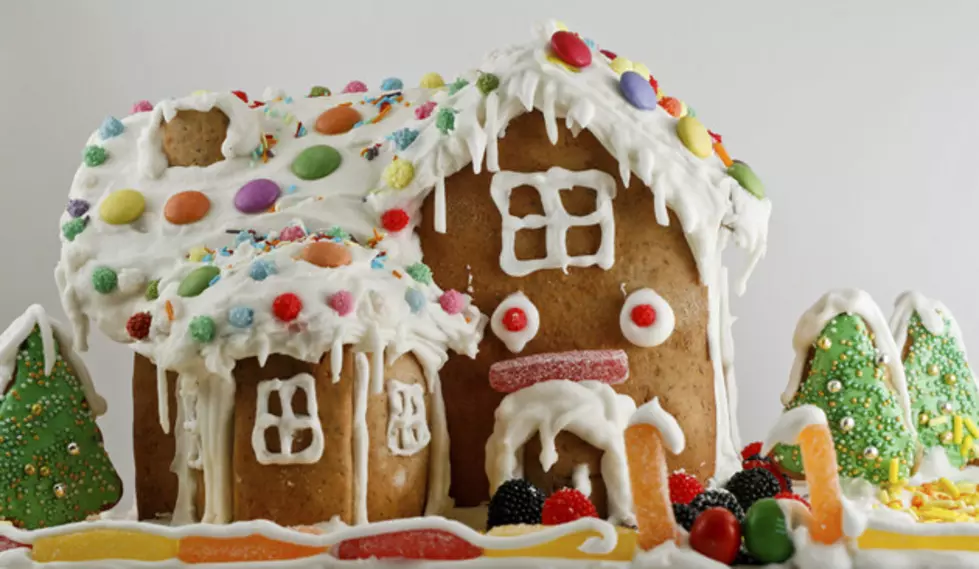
[490,167,616,277]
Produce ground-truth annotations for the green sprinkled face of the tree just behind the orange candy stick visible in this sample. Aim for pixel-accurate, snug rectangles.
[773,313,916,484]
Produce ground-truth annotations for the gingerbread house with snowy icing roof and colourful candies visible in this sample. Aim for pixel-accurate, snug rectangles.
[56,18,770,524]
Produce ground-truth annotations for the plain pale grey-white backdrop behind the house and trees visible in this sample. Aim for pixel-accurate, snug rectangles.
[0,0,979,510]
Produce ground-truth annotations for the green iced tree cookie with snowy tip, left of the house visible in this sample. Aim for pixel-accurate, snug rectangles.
[0,307,122,529]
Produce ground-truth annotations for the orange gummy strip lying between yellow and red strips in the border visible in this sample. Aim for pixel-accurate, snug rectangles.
[177,534,327,563]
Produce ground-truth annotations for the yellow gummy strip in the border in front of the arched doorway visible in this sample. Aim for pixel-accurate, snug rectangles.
[483,526,638,561]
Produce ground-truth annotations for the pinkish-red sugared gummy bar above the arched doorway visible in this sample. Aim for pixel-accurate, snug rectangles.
[489,350,629,393]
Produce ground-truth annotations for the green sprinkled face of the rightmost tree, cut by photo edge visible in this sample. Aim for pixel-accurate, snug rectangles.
[904,312,979,467]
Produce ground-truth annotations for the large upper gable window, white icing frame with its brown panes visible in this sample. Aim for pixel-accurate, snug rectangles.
[490,167,616,277]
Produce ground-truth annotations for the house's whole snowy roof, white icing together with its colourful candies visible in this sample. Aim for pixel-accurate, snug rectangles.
[56,24,771,373]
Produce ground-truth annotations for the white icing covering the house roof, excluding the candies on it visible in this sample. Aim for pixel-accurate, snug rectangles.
[56,24,771,380]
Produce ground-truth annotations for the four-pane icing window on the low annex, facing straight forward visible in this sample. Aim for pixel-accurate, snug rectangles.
[252,373,324,464]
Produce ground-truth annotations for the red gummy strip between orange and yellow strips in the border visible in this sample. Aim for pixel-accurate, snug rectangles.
[334,529,483,561]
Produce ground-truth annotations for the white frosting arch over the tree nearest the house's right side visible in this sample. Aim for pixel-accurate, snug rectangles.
[782,289,916,433]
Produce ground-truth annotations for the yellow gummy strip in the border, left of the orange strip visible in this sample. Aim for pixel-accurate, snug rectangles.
[31,529,179,563]
